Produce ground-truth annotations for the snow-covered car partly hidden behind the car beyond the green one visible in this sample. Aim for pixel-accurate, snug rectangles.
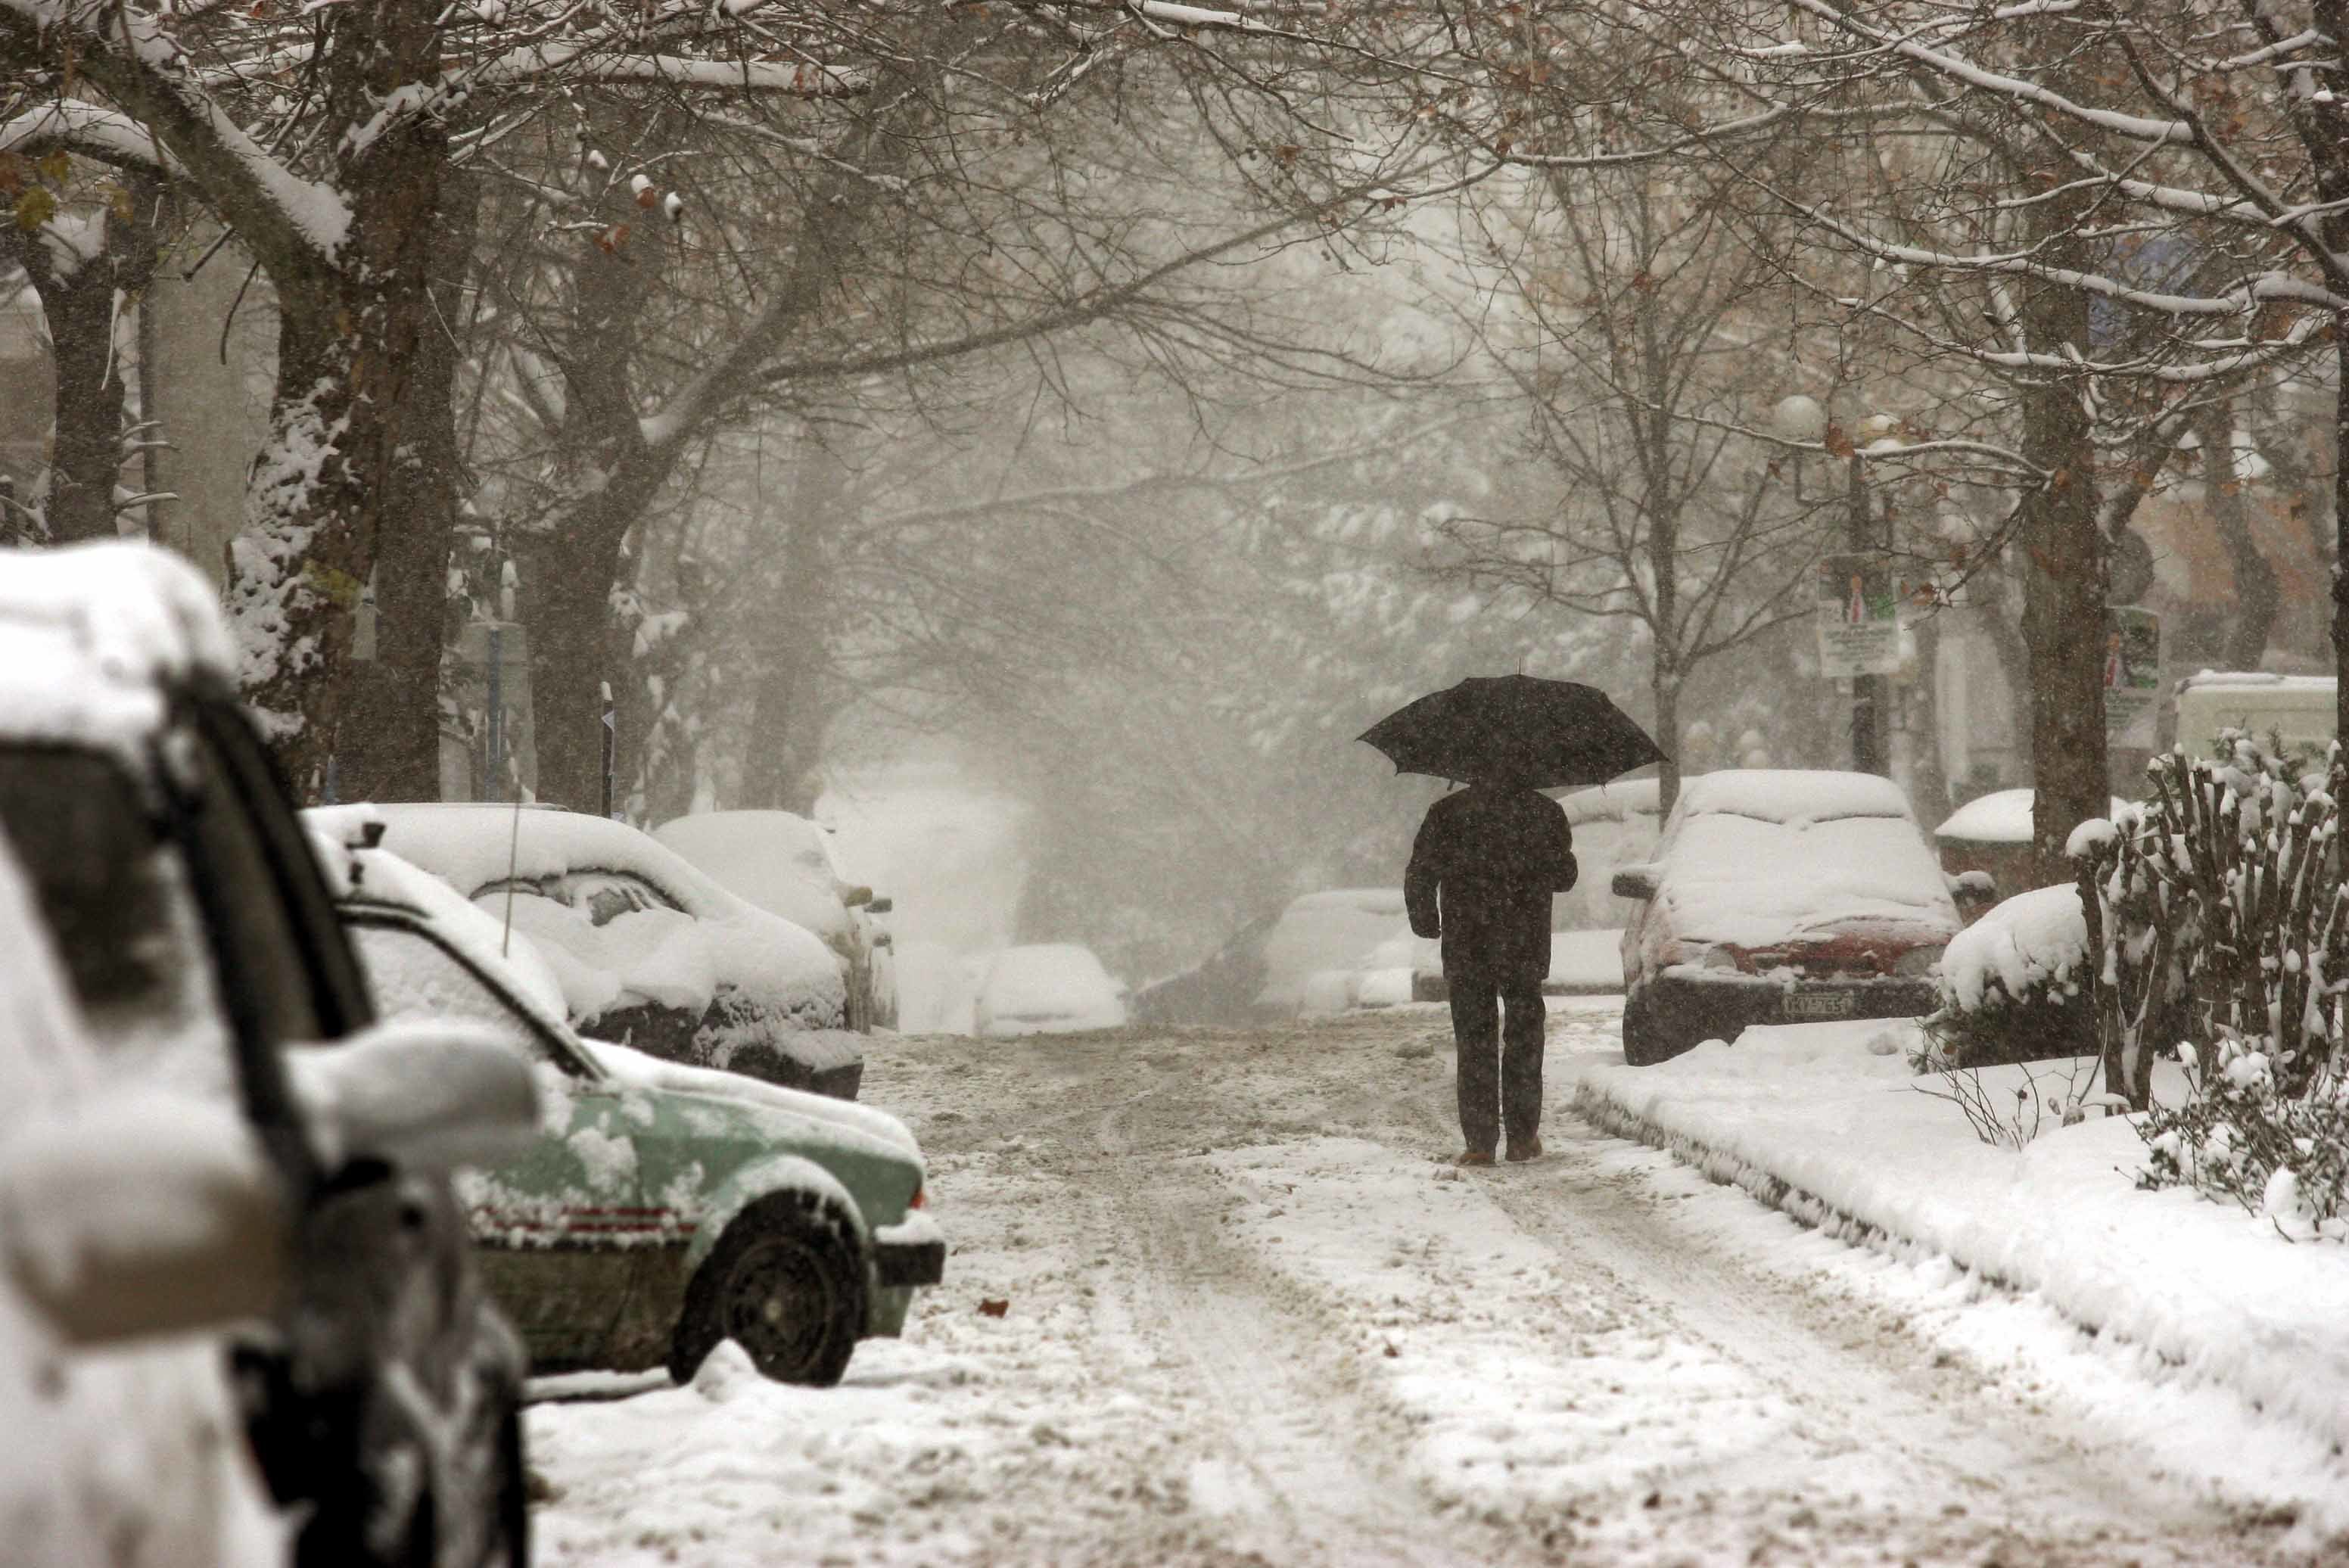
[653,812,898,1033]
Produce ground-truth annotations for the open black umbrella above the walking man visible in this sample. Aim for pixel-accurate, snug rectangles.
[1360,676,1663,789]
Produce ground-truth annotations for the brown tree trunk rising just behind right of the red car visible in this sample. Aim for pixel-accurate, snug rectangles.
[2020,235,2111,887]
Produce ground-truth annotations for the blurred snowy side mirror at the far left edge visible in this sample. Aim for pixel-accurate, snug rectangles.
[0,1089,294,1345]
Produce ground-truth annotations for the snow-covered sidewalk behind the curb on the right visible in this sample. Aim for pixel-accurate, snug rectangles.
[1553,1021,2349,1512]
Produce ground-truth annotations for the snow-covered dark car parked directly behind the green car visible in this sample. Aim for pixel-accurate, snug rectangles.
[378,803,864,1099]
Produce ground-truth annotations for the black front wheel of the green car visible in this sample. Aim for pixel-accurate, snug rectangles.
[670,1193,866,1387]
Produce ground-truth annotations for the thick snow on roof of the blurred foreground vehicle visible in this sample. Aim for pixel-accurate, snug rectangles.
[0,540,238,746]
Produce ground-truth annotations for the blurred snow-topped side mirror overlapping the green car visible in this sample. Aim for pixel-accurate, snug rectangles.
[287,1019,538,1169]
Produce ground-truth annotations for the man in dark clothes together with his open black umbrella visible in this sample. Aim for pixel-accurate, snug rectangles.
[1362,676,1663,1164]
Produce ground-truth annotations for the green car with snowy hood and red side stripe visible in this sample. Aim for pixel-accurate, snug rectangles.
[310,807,947,1385]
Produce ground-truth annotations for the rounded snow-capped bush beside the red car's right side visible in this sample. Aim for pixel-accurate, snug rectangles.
[1919,887,2095,1068]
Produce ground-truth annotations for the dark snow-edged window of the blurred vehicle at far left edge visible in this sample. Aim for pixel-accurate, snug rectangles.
[0,746,230,1080]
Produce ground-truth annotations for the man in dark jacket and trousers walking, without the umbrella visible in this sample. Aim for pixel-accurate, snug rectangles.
[1402,779,1576,1164]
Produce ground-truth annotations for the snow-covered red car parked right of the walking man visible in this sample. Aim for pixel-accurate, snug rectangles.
[1613,767,1959,1066]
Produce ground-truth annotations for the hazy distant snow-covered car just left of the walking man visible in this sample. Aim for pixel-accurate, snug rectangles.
[1134,887,1433,1023]
